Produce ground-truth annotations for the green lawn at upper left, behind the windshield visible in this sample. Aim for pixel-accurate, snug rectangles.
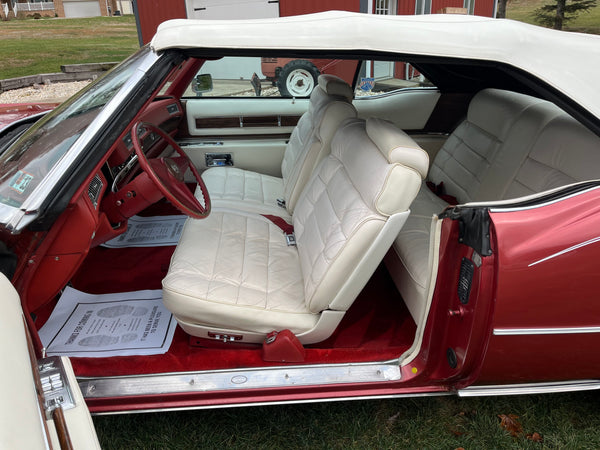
[0,16,139,79]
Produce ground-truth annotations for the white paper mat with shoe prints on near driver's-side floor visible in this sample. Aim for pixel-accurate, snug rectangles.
[39,287,177,358]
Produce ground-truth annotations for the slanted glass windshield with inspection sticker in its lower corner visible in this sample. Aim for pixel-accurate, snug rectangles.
[0,48,150,207]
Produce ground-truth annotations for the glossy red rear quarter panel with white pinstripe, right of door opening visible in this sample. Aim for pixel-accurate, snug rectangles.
[481,188,600,382]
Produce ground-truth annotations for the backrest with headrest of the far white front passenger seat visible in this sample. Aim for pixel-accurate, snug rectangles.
[281,75,357,214]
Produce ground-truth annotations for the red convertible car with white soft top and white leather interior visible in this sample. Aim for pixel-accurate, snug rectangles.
[0,12,600,442]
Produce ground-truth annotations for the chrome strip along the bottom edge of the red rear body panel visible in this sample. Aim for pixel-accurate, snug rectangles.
[457,380,600,397]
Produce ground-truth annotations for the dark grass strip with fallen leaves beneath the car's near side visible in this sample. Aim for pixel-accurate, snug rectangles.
[94,392,600,449]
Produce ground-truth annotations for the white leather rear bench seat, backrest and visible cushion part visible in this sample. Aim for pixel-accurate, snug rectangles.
[386,89,600,324]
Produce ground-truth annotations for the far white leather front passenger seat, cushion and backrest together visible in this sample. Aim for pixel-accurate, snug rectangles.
[196,75,356,217]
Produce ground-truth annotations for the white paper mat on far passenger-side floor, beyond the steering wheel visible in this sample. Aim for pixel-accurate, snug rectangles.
[102,215,187,248]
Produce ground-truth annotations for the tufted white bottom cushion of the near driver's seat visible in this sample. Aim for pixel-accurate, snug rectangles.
[159,211,318,334]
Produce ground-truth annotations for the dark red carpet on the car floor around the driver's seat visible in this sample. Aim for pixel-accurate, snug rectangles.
[63,243,416,376]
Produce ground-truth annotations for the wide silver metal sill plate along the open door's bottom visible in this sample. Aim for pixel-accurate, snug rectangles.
[78,361,401,399]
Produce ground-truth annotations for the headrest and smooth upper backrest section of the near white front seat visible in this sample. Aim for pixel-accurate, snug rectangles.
[331,118,429,216]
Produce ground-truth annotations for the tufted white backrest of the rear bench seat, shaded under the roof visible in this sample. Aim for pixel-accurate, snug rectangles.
[429,89,600,203]
